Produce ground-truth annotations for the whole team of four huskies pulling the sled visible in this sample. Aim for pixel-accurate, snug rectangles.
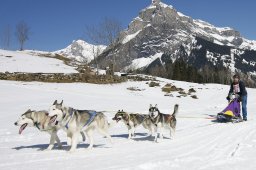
[14,100,179,152]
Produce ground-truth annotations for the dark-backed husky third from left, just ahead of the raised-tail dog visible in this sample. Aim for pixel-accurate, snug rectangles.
[112,110,155,139]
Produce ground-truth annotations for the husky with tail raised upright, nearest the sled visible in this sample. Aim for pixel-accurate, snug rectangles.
[149,104,179,142]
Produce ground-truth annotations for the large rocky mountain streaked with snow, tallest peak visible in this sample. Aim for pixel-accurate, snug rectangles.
[99,0,256,75]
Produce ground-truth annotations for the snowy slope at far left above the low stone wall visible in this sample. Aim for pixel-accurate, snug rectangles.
[0,49,77,73]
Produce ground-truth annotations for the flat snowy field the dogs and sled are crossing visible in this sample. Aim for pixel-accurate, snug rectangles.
[0,79,256,170]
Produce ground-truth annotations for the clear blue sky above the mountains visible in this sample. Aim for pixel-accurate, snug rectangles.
[0,0,256,51]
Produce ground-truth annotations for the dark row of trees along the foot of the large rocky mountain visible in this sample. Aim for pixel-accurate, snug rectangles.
[142,58,248,86]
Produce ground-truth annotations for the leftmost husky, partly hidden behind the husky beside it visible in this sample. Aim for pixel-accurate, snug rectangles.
[14,109,62,150]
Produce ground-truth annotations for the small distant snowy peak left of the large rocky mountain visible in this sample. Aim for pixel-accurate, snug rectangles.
[53,40,106,63]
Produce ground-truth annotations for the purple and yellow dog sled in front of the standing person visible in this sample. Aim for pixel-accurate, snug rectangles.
[217,97,243,123]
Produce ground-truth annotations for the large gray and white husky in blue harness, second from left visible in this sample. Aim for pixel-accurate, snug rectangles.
[49,100,112,152]
